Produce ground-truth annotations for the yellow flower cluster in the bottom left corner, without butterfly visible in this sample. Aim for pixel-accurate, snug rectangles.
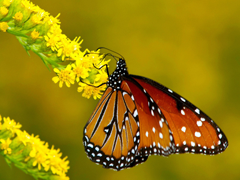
[0,116,69,180]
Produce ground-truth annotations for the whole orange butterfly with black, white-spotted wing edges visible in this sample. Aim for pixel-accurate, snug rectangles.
[83,55,228,171]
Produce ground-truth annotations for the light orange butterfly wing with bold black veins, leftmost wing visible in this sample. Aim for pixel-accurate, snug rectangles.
[83,82,147,170]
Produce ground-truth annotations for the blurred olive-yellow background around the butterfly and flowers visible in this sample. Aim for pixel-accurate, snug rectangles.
[0,0,240,180]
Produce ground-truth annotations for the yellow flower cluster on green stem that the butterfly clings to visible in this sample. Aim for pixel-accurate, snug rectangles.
[0,0,109,99]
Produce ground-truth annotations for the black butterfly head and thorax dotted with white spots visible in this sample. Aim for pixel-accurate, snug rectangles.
[107,59,128,91]
